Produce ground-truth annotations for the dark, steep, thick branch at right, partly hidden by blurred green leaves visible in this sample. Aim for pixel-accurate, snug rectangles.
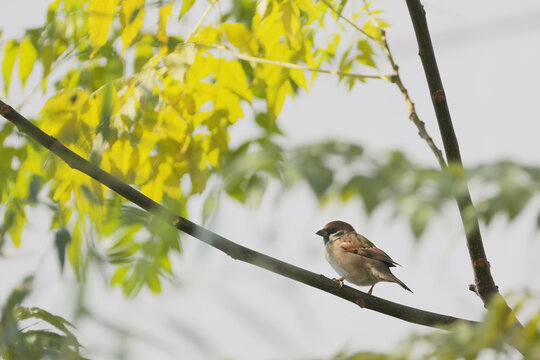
[406,0,499,304]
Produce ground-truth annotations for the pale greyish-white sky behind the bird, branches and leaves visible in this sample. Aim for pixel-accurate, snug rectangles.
[0,0,540,359]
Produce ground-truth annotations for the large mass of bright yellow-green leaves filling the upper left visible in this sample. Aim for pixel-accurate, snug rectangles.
[0,0,388,295]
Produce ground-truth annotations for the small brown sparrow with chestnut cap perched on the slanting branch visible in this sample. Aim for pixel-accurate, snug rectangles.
[316,221,412,295]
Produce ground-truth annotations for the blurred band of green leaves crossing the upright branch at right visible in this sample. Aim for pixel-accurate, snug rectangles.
[221,138,540,238]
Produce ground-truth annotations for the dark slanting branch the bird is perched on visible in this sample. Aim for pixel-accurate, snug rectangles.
[0,101,476,328]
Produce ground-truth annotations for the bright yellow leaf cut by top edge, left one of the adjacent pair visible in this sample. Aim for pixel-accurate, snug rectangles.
[88,0,119,56]
